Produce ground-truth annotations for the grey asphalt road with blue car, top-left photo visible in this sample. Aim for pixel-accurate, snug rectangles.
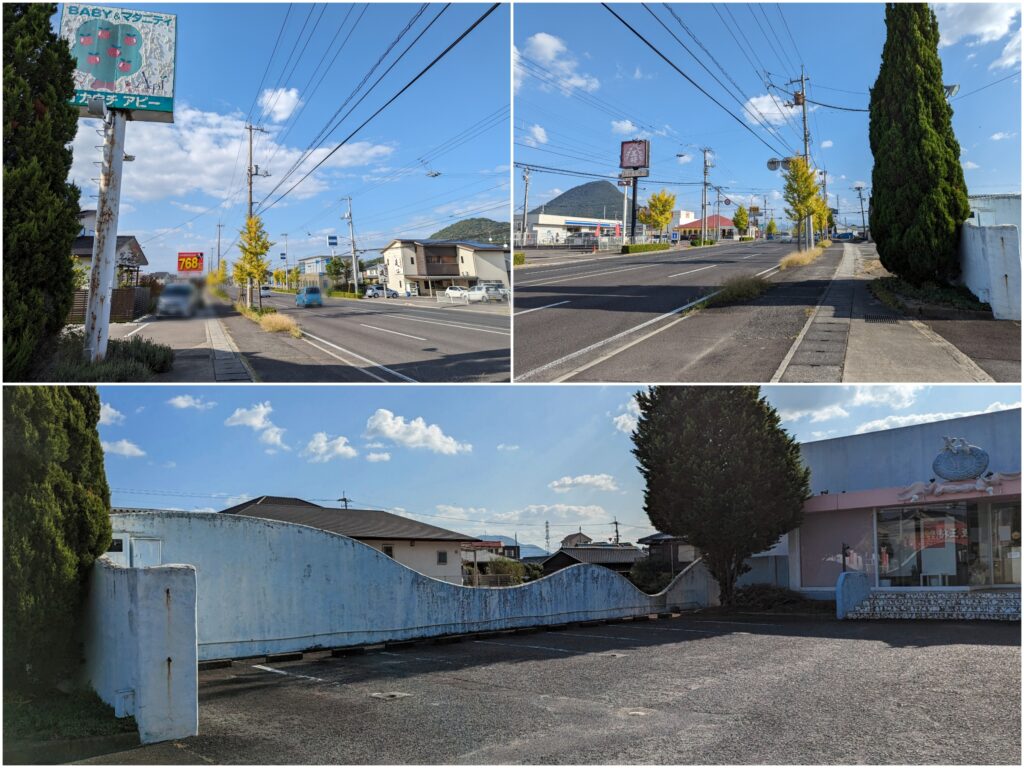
[240,294,511,382]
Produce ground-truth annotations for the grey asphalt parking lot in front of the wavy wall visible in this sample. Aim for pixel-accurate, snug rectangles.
[83,614,1021,764]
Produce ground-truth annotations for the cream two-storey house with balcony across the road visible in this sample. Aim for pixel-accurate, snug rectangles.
[381,239,511,296]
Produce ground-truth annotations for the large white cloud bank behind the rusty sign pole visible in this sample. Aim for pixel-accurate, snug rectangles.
[72,104,394,207]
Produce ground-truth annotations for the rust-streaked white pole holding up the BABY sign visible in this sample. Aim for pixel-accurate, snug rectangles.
[84,100,128,362]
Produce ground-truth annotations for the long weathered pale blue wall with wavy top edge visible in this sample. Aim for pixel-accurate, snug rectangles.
[112,512,717,659]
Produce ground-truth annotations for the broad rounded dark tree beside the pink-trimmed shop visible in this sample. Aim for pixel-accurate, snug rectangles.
[633,387,810,605]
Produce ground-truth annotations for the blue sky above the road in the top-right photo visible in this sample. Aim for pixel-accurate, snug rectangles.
[514,3,1021,224]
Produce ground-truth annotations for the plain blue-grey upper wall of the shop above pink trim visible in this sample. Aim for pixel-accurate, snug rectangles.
[800,409,1021,495]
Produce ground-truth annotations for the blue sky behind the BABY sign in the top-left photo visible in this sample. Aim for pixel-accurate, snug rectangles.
[53,3,510,271]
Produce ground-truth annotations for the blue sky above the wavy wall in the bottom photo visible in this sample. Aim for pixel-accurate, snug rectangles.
[99,385,1020,546]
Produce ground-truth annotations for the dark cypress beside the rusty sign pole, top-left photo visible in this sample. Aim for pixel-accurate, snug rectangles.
[3,3,79,381]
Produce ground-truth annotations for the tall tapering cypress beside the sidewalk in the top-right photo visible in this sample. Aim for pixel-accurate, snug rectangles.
[869,3,971,285]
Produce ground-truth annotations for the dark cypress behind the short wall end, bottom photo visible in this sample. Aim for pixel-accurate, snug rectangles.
[3,387,111,689]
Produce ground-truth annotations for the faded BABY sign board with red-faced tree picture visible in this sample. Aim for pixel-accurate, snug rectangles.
[60,3,178,123]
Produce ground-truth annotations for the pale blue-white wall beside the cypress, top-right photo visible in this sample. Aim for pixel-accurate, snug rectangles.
[961,221,1021,321]
